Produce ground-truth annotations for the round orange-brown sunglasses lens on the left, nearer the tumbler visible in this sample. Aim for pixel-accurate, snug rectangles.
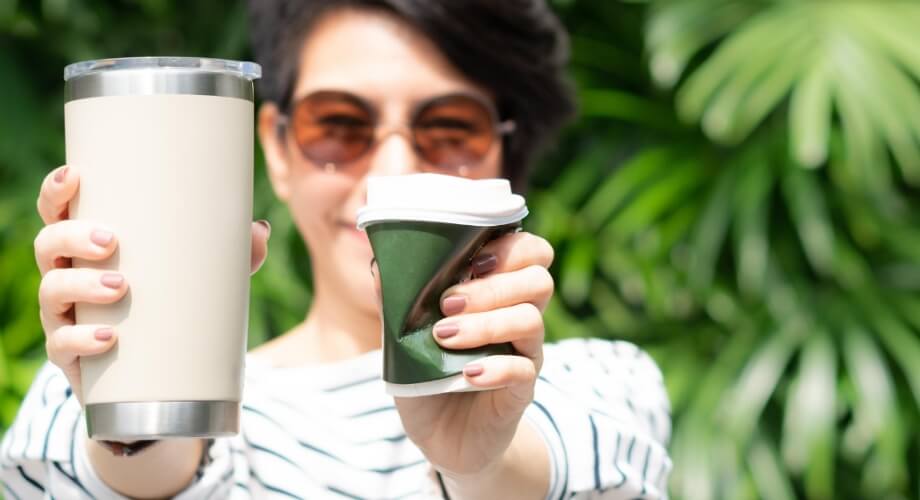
[292,92,374,167]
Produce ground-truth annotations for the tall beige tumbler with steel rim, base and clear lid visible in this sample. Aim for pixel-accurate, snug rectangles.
[64,57,260,441]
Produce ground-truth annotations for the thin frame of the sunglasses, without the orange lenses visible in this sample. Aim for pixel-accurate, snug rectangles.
[277,89,517,175]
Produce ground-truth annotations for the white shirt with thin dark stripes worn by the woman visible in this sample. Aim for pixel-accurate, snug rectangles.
[0,339,671,500]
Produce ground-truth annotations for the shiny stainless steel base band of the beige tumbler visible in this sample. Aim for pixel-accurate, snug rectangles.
[86,401,240,441]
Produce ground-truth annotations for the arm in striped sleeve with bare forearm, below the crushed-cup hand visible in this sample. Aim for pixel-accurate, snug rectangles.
[442,340,671,500]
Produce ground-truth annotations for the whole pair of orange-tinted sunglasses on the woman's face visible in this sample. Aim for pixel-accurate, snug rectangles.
[279,90,514,177]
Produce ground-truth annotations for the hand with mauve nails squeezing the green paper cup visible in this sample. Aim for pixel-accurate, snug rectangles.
[396,232,553,477]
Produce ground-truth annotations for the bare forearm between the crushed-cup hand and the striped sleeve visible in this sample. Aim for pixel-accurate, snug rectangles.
[442,420,550,500]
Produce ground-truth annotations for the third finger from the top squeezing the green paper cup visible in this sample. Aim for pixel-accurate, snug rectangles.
[433,302,543,359]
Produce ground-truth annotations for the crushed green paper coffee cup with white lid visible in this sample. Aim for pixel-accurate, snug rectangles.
[358,174,527,397]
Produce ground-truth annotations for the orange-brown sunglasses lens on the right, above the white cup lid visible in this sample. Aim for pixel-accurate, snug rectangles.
[412,96,495,170]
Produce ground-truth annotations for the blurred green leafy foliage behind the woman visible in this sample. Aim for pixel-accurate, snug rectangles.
[0,0,920,500]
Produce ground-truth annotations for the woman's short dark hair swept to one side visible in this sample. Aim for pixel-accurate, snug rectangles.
[249,0,575,191]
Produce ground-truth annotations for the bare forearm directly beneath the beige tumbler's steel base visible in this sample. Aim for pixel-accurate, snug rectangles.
[86,432,204,499]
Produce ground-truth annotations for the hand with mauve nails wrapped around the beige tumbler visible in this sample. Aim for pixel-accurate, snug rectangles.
[35,166,271,405]
